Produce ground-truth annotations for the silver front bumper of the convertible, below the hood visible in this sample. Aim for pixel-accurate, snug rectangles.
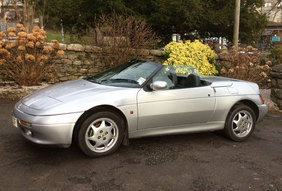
[12,103,82,147]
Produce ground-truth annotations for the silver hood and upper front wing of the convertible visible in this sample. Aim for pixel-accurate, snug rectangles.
[21,79,139,115]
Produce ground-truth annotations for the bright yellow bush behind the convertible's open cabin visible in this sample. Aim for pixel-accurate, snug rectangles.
[163,40,218,76]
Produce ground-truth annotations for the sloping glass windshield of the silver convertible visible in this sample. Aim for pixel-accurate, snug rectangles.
[85,60,159,88]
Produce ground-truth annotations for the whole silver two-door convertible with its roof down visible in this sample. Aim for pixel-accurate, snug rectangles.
[12,60,267,157]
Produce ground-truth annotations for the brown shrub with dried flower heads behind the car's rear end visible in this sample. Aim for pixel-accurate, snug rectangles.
[219,46,271,87]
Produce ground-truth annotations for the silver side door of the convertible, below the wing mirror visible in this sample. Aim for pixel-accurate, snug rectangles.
[137,65,215,130]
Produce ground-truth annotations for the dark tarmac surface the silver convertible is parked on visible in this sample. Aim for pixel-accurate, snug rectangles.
[0,100,282,191]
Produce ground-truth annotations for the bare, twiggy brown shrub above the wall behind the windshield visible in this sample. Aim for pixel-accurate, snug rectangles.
[94,14,157,67]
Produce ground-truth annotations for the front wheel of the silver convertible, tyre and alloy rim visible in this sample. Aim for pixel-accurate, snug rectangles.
[76,111,124,157]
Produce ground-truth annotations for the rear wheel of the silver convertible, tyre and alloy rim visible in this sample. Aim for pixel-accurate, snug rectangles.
[224,104,256,141]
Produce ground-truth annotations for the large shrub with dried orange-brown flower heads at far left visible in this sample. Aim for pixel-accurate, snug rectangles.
[0,24,64,86]
